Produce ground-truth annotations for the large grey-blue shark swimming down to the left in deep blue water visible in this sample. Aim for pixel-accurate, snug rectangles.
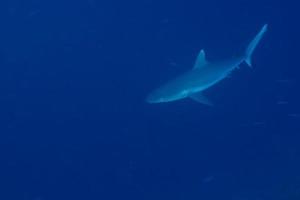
[146,24,268,106]
